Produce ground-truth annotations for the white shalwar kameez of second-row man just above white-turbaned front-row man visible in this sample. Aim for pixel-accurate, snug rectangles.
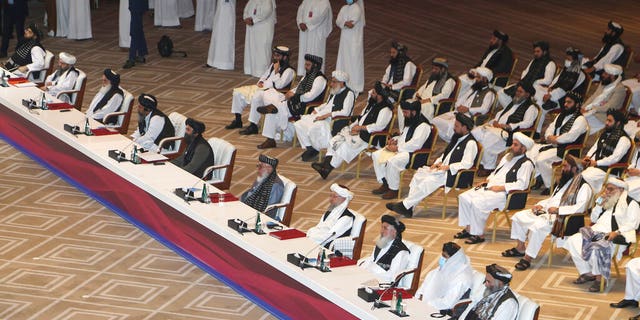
[471,100,538,170]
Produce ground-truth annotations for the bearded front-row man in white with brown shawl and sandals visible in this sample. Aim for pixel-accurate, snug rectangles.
[502,157,592,270]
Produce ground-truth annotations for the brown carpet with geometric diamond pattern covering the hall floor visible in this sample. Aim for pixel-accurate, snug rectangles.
[0,0,640,319]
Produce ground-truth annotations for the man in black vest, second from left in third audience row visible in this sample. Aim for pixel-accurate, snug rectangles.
[498,41,556,119]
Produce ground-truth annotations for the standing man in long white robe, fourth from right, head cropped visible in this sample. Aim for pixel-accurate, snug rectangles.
[207,0,236,70]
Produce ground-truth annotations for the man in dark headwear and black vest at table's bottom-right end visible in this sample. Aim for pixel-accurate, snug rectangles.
[464,263,518,320]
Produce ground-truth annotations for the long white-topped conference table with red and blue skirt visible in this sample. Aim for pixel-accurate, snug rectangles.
[0,80,444,319]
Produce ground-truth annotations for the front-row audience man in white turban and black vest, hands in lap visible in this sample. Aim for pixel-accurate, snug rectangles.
[454,132,533,244]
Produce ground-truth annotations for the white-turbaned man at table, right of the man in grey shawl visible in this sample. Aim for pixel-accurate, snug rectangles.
[307,183,355,248]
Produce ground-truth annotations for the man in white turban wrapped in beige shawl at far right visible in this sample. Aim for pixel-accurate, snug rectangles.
[582,64,626,135]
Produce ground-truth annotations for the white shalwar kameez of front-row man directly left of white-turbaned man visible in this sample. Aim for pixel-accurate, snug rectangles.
[402,134,478,209]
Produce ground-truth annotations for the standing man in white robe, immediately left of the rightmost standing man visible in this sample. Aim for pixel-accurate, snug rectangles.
[296,0,333,76]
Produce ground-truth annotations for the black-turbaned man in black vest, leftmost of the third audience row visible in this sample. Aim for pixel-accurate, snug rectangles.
[458,30,513,99]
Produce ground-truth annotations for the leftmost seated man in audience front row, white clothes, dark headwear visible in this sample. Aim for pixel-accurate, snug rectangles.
[225,46,295,131]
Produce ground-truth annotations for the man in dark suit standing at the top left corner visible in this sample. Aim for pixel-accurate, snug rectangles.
[0,0,29,58]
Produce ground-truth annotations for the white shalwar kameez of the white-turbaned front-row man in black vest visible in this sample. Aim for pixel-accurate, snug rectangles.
[458,155,533,236]
